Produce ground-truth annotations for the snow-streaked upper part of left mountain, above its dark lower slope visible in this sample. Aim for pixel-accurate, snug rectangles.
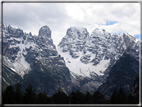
[3,25,61,77]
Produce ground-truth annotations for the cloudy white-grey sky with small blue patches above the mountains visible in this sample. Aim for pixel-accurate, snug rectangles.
[3,3,141,46]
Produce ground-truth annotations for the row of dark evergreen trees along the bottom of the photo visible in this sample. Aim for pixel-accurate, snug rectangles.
[2,83,139,104]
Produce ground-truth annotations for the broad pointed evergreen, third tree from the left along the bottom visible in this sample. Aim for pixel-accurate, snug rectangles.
[23,84,37,104]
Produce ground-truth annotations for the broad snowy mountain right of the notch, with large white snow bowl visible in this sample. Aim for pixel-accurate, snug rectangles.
[57,27,139,90]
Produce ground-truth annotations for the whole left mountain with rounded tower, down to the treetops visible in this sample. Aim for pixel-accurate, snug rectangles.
[3,25,75,95]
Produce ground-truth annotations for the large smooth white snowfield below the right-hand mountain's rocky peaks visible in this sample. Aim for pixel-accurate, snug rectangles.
[57,47,110,78]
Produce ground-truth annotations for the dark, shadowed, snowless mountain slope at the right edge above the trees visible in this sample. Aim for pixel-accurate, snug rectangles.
[98,48,139,97]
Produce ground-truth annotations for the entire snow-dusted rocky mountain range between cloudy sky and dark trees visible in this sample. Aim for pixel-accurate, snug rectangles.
[2,24,141,96]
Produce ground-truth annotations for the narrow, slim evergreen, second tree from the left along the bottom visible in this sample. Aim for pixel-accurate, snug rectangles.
[15,83,23,104]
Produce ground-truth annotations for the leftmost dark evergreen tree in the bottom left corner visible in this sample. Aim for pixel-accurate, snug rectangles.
[2,85,16,104]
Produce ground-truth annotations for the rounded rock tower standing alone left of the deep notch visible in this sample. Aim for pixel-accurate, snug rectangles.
[39,25,51,38]
